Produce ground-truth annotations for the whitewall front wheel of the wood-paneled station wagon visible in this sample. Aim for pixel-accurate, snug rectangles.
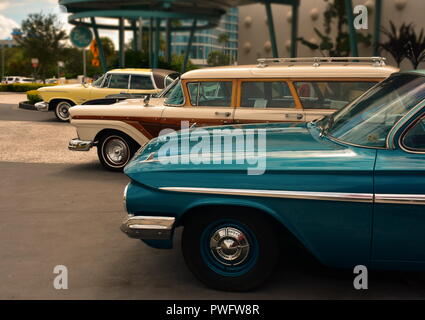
[97,132,140,171]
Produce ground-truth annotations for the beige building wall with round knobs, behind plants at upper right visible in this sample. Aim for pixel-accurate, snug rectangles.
[238,0,425,70]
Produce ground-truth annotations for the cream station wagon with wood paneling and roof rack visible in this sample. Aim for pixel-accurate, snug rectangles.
[69,57,398,170]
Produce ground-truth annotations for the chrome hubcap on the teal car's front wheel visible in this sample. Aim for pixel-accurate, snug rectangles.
[210,227,249,266]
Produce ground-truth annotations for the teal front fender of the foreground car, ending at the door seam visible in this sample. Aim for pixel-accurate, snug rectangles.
[126,122,376,267]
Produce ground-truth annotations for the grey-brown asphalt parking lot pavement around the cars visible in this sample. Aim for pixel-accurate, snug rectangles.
[0,95,425,299]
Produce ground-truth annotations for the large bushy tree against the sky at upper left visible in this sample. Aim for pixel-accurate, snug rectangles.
[17,13,68,79]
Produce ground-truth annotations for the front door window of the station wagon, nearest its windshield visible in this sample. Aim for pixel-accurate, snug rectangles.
[187,81,232,107]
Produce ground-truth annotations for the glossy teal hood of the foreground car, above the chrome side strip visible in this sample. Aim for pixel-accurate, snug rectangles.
[125,123,375,187]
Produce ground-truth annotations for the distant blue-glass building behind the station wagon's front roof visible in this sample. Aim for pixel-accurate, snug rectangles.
[171,8,239,66]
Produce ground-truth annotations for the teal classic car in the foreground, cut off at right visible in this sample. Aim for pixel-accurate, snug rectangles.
[121,71,425,291]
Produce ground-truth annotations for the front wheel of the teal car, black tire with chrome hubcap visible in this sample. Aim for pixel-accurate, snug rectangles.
[182,210,279,291]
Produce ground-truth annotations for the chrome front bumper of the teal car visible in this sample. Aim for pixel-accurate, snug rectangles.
[121,216,176,240]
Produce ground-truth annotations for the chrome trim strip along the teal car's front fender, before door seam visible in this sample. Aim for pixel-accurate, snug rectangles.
[159,187,373,203]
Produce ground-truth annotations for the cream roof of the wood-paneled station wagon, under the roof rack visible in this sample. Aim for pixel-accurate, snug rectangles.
[182,63,399,79]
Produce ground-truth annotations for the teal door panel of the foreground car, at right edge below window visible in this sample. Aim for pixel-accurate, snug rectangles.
[372,150,425,268]
